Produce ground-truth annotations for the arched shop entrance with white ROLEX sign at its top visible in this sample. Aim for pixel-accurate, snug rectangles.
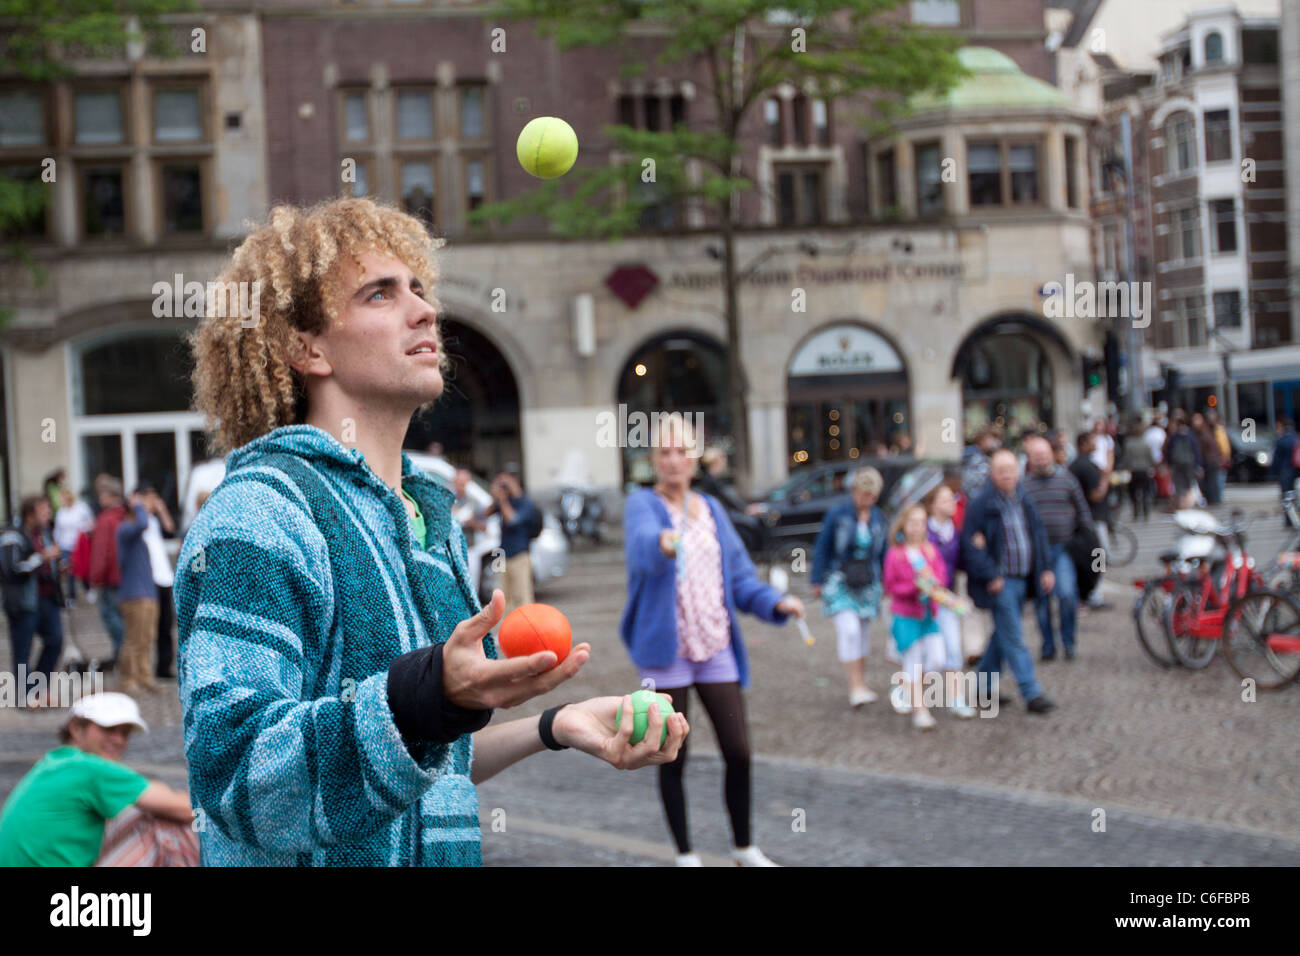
[785,323,911,468]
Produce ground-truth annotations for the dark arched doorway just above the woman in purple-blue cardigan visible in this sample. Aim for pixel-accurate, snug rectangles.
[616,332,732,484]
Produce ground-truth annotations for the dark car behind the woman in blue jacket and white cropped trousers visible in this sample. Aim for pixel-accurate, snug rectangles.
[757,455,922,559]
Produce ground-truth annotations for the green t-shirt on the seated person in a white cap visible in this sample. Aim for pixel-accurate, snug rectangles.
[0,747,150,866]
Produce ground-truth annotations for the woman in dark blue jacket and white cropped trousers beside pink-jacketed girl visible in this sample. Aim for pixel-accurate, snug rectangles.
[813,468,900,708]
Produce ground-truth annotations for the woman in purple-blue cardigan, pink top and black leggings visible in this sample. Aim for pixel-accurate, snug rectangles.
[619,419,803,866]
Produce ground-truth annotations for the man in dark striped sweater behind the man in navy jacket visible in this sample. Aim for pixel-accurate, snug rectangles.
[1023,436,1092,661]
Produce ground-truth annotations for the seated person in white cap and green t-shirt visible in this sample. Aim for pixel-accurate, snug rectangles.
[0,693,199,866]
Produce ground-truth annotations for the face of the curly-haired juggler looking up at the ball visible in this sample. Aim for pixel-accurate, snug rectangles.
[295,252,443,411]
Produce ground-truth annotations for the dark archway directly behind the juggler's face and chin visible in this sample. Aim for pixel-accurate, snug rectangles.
[403,319,523,476]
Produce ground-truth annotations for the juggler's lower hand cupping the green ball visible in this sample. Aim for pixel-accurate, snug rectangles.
[551,695,690,770]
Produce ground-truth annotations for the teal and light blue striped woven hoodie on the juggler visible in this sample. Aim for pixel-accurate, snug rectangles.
[174,425,497,866]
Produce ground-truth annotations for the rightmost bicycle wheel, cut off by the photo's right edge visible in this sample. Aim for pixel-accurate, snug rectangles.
[1223,591,1300,691]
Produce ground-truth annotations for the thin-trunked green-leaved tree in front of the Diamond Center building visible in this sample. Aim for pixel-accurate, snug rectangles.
[471,0,962,488]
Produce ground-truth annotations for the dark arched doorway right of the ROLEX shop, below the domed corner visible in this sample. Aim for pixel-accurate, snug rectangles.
[953,315,1074,438]
